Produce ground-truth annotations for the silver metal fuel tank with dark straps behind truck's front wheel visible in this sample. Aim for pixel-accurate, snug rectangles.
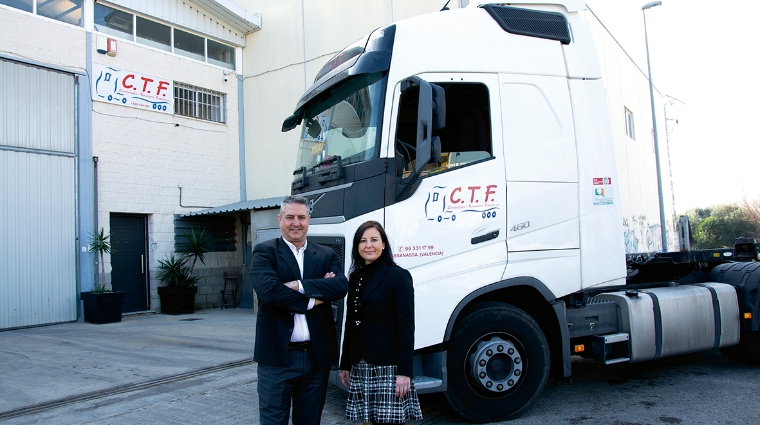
[596,282,739,362]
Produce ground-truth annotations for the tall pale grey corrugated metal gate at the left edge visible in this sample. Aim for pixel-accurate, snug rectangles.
[0,59,77,329]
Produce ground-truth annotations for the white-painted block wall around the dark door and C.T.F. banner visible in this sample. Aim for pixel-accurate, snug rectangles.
[89,29,242,311]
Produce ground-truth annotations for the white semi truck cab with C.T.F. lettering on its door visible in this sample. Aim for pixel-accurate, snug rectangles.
[283,0,760,422]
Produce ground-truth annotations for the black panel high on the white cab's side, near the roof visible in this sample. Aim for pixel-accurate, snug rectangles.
[481,4,570,44]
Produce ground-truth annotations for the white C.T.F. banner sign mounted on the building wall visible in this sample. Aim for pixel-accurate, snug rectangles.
[90,63,174,114]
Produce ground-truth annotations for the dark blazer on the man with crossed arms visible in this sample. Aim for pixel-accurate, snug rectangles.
[251,238,348,368]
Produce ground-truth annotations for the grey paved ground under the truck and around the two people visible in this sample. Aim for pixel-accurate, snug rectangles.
[0,309,760,425]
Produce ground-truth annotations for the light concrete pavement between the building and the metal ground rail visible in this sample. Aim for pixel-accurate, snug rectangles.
[0,309,256,420]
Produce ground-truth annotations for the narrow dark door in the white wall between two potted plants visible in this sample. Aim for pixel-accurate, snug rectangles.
[111,214,149,313]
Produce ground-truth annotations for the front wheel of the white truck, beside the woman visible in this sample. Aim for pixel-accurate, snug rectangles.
[446,302,550,422]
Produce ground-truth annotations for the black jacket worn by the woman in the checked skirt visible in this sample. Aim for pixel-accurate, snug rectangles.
[340,263,414,378]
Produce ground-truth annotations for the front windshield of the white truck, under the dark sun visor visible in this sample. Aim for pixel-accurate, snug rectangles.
[298,72,386,174]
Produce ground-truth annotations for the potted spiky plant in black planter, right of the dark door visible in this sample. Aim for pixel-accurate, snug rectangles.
[156,228,213,314]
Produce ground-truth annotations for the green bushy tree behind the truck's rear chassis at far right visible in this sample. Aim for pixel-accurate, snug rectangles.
[687,204,760,249]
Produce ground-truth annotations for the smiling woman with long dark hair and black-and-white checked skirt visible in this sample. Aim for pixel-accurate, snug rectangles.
[340,221,422,424]
